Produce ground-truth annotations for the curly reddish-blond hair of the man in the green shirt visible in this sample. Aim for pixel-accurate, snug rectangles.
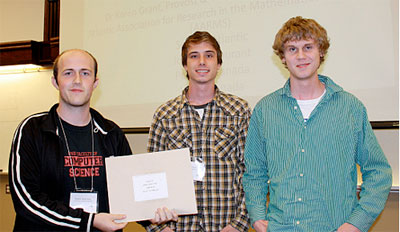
[272,16,329,63]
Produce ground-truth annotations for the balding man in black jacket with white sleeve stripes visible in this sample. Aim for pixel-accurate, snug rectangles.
[9,49,177,231]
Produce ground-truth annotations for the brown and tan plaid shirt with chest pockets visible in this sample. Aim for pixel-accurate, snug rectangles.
[146,87,250,231]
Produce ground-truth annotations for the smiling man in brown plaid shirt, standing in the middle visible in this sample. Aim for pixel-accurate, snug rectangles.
[146,31,250,232]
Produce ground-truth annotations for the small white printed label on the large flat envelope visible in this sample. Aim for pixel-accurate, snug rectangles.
[132,172,168,201]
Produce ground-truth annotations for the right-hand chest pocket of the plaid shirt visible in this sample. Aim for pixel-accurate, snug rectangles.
[214,127,238,159]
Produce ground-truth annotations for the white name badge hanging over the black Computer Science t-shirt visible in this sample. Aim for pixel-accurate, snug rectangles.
[69,192,98,213]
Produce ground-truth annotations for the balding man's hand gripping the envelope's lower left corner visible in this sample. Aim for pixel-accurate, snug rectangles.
[93,213,128,231]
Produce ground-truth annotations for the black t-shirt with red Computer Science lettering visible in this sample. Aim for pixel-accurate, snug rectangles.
[59,118,109,212]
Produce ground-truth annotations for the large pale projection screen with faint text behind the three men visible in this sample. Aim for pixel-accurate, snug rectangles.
[60,0,399,127]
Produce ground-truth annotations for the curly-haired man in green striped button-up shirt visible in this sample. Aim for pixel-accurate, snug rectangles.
[243,17,392,231]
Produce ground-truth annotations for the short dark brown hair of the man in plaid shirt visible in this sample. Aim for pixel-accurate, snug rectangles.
[182,31,222,66]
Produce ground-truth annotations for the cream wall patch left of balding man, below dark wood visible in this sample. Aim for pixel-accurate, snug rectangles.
[0,71,58,171]
